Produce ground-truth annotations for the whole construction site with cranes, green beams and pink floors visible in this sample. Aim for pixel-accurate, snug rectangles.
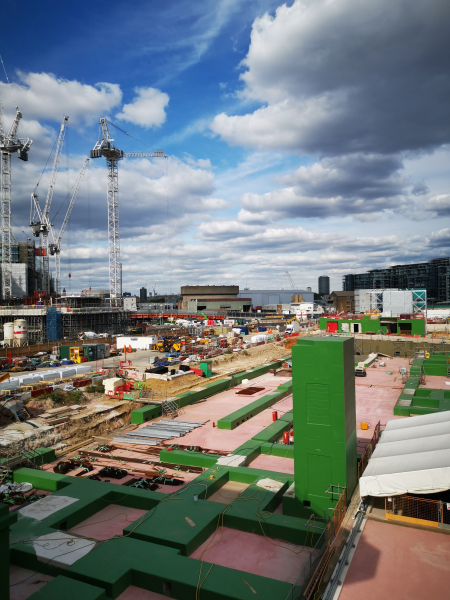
[0,42,450,600]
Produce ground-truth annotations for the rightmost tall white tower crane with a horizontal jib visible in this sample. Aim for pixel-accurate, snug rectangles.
[90,118,167,303]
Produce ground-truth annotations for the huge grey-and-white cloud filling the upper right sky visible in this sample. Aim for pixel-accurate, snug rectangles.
[210,0,450,155]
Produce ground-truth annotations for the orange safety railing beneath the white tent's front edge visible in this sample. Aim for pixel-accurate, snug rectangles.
[384,496,450,527]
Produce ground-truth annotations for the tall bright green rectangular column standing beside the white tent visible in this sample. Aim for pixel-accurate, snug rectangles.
[292,337,357,517]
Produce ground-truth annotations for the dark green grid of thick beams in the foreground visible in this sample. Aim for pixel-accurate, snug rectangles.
[7,466,321,600]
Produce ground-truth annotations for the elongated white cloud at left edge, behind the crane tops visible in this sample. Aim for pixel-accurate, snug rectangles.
[0,71,122,125]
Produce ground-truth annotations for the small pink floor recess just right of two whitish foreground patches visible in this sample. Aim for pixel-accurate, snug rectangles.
[69,504,147,541]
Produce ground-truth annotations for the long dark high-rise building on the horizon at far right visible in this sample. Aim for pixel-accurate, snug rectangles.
[342,258,450,304]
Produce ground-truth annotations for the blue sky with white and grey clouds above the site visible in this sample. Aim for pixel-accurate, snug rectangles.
[0,0,450,292]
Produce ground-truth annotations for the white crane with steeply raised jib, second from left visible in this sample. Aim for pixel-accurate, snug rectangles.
[30,116,69,294]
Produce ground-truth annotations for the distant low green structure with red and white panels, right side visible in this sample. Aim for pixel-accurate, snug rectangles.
[319,315,426,336]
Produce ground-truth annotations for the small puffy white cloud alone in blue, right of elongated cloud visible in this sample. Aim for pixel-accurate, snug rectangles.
[116,87,169,128]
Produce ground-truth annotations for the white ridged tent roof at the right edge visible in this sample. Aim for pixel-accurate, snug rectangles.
[359,412,450,497]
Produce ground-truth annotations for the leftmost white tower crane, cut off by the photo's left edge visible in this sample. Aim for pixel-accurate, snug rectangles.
[0,99,33,300]
